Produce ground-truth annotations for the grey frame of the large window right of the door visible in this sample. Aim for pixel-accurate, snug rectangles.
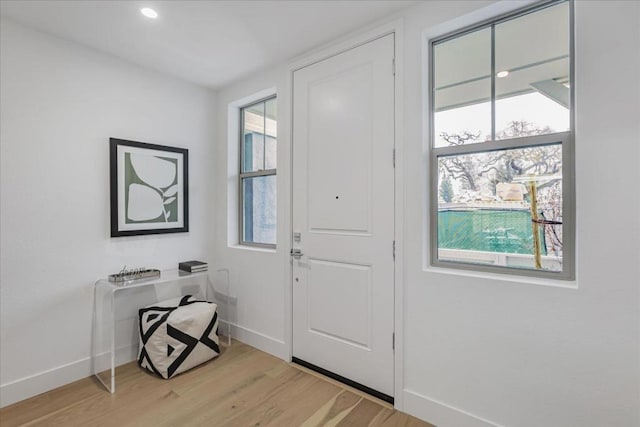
[427,0,576,281]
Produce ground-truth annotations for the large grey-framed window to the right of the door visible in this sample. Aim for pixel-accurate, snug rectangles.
[430,1,575,279]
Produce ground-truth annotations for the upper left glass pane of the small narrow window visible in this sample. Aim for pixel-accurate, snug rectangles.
[242,102,265,172]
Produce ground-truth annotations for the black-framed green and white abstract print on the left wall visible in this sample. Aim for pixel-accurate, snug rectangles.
[109,138,189,237]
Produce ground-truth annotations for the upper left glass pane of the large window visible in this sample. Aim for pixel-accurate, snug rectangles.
[433,28,491,147]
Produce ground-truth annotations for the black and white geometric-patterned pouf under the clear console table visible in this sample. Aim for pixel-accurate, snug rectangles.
[138,295,220,379]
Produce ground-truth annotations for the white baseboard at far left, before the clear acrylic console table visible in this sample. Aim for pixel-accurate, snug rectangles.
[0,358,92,408]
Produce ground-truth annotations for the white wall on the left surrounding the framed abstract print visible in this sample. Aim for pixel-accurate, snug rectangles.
[0,19,216,405]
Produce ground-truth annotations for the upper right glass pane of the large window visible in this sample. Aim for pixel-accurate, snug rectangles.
[495,3,571,139]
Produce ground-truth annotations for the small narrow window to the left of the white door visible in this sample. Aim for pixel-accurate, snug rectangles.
[239,97,277,247]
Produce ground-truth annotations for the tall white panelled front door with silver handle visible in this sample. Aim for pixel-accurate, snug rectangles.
[292,34,394,396]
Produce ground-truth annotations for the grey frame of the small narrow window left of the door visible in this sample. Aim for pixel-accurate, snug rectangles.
[238,94,278,249]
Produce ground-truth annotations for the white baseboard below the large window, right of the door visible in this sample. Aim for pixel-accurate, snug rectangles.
[403,389,501,427]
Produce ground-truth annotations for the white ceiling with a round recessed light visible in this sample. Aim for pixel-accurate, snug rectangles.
[0,0,418,89]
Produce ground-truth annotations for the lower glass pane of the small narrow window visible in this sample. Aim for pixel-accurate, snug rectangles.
[242,175,276,245]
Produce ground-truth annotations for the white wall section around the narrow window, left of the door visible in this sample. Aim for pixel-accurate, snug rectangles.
[211,66,290,359]
